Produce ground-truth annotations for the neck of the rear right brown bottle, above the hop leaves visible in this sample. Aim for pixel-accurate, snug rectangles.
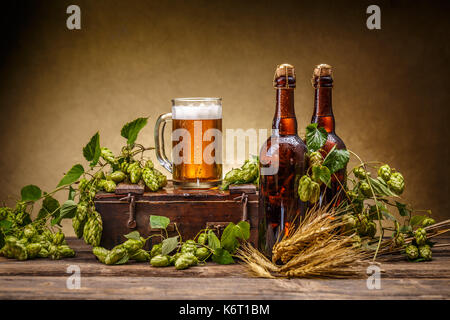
[311,77,335,133]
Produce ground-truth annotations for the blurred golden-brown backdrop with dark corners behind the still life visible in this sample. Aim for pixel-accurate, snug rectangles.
[0,0,450,232]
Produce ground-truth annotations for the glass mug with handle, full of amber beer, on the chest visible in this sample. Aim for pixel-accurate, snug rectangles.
[155,98,222,189]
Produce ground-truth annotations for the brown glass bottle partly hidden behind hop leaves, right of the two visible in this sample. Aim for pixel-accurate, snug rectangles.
[311,64,347,205]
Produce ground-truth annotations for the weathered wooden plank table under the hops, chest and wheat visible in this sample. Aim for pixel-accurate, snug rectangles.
[0,238,450,300]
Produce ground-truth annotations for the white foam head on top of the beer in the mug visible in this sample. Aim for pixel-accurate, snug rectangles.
[172,103,222,120]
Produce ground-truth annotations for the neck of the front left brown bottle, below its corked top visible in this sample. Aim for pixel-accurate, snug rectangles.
[272,88,297,135]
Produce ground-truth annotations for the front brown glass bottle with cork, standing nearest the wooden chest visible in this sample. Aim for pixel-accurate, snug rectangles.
[259,64,306,257]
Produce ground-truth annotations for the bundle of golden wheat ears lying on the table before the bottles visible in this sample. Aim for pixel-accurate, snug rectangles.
[237,207,367,278]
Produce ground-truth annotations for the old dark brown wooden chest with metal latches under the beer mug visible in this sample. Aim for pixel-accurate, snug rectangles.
[95,182,258,249]
